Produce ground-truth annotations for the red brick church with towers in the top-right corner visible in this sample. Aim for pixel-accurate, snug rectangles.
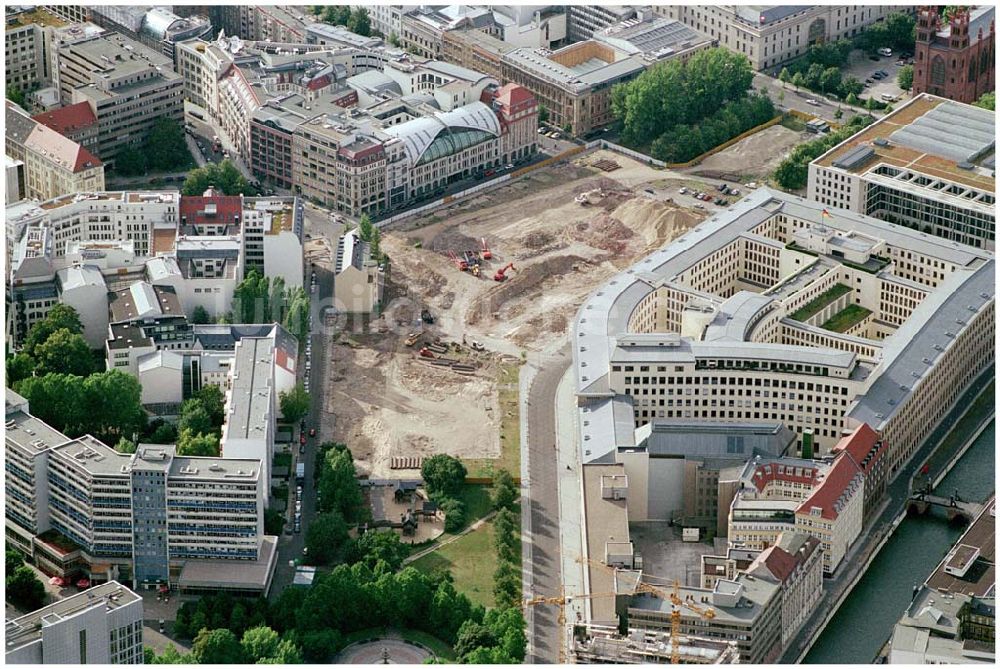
[913,6,995,102]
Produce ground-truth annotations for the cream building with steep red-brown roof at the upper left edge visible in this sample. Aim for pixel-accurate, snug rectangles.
[5,100,104,200]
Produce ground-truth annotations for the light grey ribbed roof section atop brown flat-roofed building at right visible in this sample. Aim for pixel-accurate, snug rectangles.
[889,100,996,163]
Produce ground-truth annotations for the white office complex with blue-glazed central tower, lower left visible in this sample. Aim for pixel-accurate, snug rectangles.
[5,389,276,593]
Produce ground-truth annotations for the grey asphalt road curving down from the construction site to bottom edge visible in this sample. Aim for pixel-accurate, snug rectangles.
[521,347,571,664]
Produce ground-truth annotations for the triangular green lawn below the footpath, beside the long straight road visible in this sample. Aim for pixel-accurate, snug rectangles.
[410,523,497,606]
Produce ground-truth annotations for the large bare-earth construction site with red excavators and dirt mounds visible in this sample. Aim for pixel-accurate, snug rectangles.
[327,151,706,478]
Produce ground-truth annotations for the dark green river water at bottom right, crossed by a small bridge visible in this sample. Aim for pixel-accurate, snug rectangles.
[804,421,996,664]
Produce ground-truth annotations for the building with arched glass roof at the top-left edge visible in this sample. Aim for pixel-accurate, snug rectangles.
[90,5,212,62]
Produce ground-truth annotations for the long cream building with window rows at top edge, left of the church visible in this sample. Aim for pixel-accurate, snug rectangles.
[653,5,909,70]
